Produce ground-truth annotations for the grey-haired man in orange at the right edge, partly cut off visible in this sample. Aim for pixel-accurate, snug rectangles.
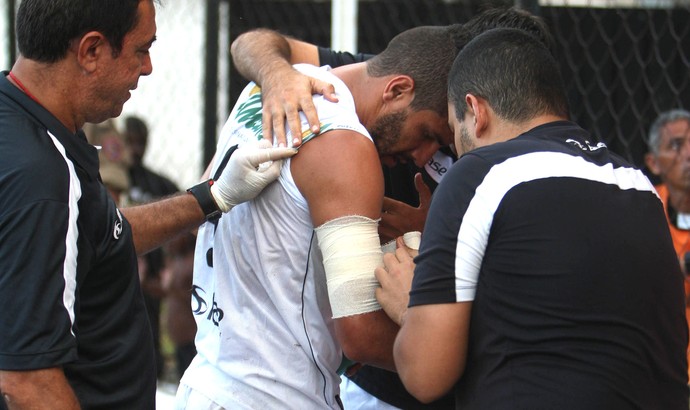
[645,109,690,382]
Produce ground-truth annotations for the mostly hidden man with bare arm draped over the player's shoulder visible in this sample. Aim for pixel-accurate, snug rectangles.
[232,8,555,409]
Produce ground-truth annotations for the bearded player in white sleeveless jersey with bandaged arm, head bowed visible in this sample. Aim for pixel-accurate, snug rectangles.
[177,26,462,409]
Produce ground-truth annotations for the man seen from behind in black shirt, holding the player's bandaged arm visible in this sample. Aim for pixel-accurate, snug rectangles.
[376,29,688,410]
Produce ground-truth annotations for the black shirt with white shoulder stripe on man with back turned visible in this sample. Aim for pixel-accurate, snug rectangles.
[410,121,688,410]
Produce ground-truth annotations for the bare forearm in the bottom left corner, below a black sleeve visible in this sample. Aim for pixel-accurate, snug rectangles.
[0,368,80,410]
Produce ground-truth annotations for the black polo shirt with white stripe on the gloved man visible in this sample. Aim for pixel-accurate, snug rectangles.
[0,72,156,409]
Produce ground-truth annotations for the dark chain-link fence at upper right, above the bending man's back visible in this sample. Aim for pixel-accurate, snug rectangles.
[541,1,690,173]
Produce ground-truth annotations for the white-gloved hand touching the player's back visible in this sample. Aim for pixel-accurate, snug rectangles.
[211,140,297,212]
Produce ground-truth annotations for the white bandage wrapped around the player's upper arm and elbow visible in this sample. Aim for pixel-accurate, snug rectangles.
[316,216,383,319]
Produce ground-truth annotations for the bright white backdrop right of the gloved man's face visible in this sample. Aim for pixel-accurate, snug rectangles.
[119,0,205,189]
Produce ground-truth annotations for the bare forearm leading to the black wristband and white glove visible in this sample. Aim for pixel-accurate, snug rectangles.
[122,193,205,255]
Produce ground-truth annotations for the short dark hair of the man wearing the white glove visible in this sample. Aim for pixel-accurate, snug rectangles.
[16,0,146,63]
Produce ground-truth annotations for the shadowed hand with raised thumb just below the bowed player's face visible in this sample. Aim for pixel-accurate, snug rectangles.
[379,173,431,242]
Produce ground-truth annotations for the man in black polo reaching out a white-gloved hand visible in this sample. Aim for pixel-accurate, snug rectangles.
[0,0,294,409]
